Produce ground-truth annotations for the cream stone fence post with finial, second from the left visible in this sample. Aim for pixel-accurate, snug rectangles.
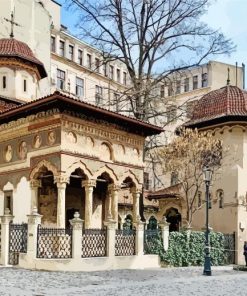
[27,207,42,259]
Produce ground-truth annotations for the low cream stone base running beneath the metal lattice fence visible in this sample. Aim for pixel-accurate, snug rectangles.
[18,254,160,271]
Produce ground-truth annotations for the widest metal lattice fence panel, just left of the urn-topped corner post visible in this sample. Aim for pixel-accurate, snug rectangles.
[37,225,72,259]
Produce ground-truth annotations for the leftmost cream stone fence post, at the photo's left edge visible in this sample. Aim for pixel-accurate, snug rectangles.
[0,208,14,266]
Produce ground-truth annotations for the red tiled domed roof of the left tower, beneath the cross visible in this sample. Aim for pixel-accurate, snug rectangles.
[0,38,47,78]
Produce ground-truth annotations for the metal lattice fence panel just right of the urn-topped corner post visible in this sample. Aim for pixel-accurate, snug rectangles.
[81,229,107,258]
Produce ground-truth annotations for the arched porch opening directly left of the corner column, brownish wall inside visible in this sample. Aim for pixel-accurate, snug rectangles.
[34,166,57,226]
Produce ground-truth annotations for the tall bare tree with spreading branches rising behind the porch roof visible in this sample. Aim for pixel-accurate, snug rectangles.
[66,0,234,125]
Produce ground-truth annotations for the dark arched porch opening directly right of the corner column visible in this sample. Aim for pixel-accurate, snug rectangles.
[65,168,87,227]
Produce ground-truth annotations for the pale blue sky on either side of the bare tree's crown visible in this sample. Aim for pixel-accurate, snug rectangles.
[58,0,247,66]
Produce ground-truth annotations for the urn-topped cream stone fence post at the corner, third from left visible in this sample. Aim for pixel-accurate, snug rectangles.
[69,212,84,259]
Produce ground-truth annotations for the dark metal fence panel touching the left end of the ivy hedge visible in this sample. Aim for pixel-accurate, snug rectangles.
[144,229,162,254]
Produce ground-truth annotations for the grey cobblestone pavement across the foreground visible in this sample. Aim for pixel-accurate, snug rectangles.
[0,267,247,296]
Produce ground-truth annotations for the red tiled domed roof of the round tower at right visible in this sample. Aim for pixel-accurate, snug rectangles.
[186,85,247,126]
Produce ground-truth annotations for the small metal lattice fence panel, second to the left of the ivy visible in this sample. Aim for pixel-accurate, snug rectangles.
[115,229,136,256]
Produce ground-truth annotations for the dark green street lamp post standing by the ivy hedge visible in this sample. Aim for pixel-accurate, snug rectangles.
[203,167,213,275]
